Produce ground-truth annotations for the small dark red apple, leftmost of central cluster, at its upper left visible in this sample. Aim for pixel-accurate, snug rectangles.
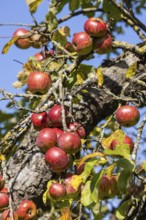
[31,112,49,130]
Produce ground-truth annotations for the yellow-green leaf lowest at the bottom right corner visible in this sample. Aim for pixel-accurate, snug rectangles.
[116,200,131,220]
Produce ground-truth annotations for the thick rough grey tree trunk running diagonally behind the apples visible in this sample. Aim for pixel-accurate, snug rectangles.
[4,50,146,211]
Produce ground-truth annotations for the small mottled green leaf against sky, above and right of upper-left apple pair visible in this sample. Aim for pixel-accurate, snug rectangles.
[46,11,58,32]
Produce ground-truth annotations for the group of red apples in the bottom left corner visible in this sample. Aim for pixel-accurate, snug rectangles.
[0,175,37,220]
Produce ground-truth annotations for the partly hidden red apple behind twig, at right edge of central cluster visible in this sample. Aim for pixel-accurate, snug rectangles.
[68,122,86,139]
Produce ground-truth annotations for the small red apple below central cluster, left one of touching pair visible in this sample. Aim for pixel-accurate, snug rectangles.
[49,183,66,201]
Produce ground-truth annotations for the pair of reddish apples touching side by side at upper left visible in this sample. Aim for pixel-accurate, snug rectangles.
[13,28,48,49]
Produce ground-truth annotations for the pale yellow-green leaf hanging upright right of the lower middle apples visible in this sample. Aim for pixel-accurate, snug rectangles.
[81,180,93,206]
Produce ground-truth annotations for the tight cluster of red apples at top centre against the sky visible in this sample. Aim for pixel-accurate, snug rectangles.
[65,18,112,56]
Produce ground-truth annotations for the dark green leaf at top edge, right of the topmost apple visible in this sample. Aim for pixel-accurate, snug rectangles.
[102,0,121,21]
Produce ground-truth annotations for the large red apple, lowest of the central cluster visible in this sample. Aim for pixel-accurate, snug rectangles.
[45,147,70,173]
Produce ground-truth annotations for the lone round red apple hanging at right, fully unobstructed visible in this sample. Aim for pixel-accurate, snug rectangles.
[115,105,140,127]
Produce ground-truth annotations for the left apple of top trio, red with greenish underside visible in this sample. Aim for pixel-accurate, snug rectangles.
[72,32,93,55]
